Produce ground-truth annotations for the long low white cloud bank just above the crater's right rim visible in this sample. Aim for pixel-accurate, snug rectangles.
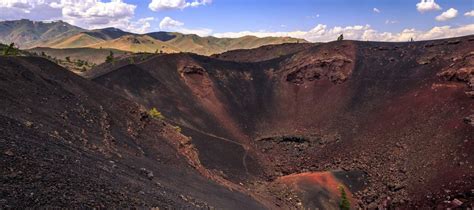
[213,24,474,42]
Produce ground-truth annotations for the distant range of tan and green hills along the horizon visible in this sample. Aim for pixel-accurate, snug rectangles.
[0,20,307,55]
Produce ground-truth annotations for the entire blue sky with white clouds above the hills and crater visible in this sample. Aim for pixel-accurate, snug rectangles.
[0,0,474,42]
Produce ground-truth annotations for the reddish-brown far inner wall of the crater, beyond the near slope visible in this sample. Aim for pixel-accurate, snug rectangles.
[94,36,474,208]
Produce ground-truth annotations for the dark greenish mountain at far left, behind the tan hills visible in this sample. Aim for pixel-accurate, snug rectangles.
[0,19,85,48]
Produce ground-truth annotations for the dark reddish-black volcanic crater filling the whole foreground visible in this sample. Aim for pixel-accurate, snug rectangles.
[0,36,474,209]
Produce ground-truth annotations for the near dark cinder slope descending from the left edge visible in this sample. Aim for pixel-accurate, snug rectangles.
[0,57,270,209]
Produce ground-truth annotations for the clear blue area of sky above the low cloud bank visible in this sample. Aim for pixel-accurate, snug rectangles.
[126,0,474,33]
